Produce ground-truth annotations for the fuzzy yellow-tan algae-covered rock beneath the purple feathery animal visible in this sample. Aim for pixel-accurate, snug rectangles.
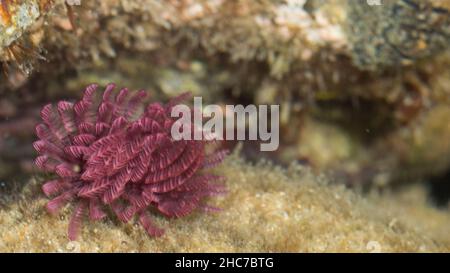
[0,155,450,252]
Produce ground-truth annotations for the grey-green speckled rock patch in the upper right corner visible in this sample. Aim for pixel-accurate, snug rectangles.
[348,0,450,69]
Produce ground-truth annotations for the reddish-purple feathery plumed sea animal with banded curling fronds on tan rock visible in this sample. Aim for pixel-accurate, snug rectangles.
[34,84,226,240]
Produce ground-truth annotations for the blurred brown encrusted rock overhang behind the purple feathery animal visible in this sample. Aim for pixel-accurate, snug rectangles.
[0,0,450,186]
